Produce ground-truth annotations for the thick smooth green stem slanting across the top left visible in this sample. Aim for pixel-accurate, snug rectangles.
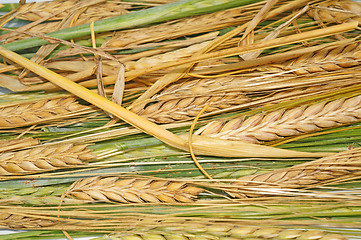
[3,0,260,51]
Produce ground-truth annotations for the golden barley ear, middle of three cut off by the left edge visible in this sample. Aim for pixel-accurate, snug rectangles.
[0,144,94,175]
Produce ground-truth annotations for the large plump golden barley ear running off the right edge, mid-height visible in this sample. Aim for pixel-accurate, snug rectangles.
[196,96,361,143]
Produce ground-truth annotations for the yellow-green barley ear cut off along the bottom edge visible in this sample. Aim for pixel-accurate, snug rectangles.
[106,224,348,240]
